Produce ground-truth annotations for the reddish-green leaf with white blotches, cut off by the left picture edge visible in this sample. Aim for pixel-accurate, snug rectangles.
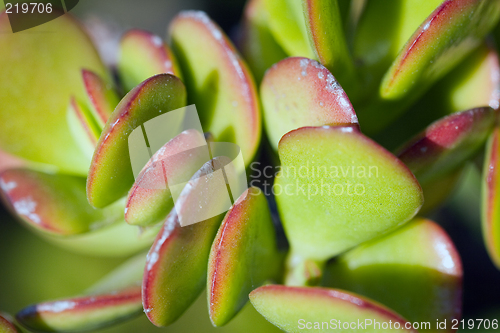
[0,169,120,236]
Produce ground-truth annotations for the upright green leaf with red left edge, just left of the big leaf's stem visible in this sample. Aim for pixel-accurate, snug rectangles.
[207,187,282,326]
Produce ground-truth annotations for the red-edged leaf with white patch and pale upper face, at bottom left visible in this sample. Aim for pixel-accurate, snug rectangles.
[17,253,146,332]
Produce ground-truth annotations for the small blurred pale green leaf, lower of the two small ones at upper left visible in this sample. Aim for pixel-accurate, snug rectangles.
[67,97,101,158]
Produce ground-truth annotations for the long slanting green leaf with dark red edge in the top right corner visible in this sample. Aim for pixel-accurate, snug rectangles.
[357,0,500,134]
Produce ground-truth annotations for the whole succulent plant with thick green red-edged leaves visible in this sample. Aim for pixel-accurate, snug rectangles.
[0,0,500,332]
